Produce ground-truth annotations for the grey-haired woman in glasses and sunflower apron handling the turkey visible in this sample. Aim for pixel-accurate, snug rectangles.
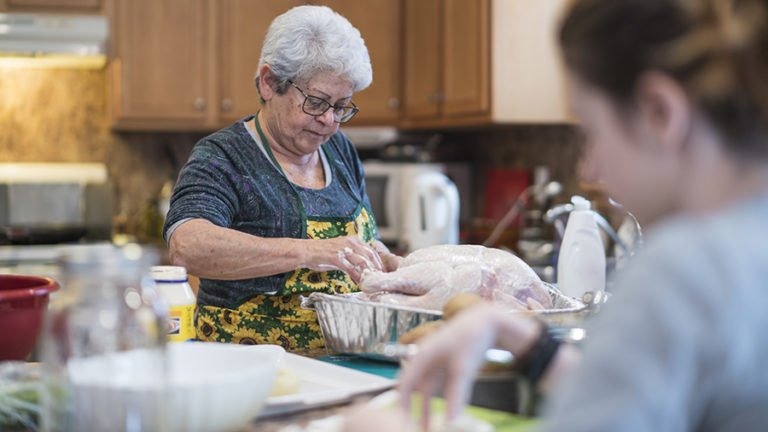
[164,6,397,350]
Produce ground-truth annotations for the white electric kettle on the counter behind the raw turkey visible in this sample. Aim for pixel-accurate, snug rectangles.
[399,171,459,252]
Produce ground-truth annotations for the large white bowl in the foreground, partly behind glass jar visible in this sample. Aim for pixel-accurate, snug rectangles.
[67,342,285,432]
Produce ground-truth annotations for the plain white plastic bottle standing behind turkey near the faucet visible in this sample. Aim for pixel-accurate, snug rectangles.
[557,195,605,298]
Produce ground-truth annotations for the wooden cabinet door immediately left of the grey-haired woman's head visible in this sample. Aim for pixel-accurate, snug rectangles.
[215,0,303,126]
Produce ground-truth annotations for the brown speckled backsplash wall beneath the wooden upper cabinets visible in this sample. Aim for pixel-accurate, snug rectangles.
[0,68,580,243]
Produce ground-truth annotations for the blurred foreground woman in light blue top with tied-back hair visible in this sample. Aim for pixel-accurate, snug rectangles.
[348,0,768,432]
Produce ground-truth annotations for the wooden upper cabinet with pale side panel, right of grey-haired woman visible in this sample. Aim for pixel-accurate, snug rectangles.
[401,0,573,128]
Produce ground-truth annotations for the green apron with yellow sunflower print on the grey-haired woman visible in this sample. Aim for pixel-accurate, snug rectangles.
[197,118,376,351]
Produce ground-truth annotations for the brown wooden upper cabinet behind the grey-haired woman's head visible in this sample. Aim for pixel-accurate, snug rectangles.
[110,0,401,131]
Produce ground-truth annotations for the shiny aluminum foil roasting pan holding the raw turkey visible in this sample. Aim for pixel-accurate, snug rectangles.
[301,286,586,361]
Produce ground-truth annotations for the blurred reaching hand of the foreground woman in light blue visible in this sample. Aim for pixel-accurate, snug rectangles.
[398,304,540,428]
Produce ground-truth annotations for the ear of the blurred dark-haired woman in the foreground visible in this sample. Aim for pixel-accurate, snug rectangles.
[636,71,693,151]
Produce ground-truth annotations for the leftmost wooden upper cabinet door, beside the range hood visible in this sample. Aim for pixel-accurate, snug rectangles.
[111,0,215,129]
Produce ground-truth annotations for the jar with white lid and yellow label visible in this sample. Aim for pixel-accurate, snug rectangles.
[151,266,197,342]
